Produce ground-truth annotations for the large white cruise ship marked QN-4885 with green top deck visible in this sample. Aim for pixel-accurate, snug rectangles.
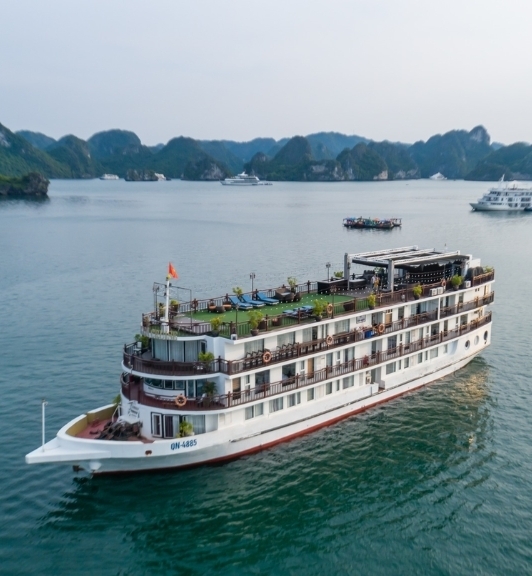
[26,246,494,474]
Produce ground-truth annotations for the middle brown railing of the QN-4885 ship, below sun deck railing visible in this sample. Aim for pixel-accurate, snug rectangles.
[124,292,495,376]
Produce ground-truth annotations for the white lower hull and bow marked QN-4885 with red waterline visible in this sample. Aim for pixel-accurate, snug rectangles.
[26,334,489,474]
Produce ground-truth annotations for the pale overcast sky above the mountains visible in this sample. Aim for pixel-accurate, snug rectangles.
[0,0,532,144]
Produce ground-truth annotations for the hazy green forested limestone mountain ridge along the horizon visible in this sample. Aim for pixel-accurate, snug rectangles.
[5,124,532,182]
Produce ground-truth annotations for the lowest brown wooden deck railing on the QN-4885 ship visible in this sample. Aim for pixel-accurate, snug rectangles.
[121,312,491,411]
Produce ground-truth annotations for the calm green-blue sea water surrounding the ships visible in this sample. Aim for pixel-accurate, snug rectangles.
[0,180,532,576]
